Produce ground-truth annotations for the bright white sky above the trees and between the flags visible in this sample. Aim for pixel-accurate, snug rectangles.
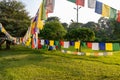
[19,0,120,24]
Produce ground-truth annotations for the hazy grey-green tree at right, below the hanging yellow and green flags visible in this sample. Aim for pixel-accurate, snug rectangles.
[96,17,115,41]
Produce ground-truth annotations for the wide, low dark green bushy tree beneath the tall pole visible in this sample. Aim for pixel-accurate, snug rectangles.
[66,28,95,41]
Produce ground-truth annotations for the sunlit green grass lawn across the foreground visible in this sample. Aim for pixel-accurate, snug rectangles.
[0,46,120,80]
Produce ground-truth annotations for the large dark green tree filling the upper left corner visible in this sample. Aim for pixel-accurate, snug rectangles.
[0,0,30,37]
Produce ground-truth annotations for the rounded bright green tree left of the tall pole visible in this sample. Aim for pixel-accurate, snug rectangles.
[40,21,66,40]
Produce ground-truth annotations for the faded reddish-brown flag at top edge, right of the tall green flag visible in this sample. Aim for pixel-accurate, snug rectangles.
[45,0,55,13]
